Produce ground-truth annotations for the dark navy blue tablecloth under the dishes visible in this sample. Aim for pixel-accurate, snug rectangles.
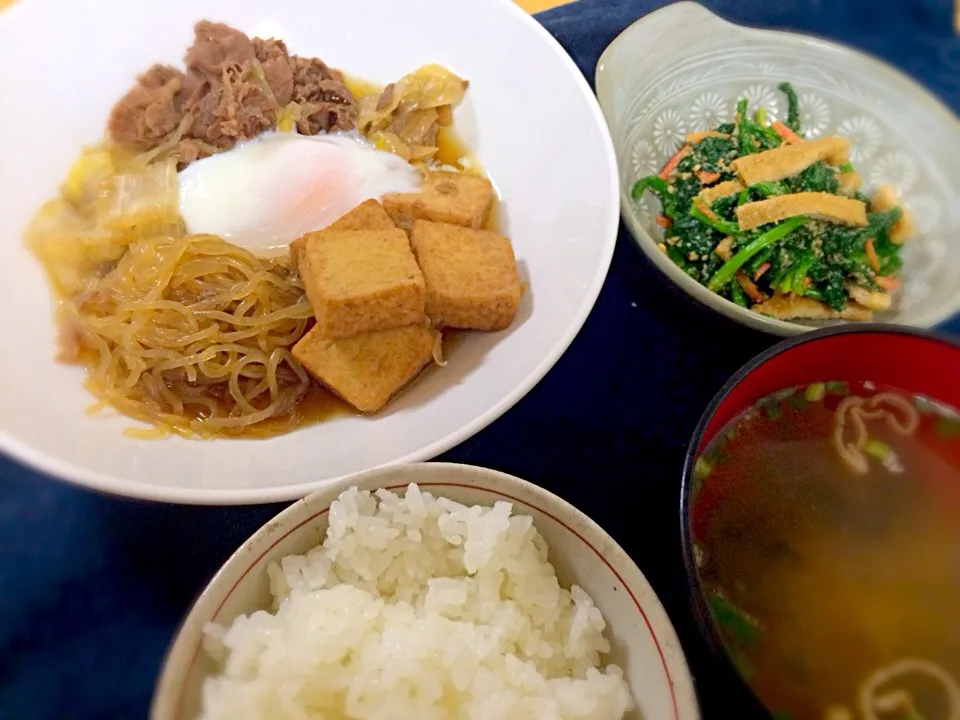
[0,0,960,720]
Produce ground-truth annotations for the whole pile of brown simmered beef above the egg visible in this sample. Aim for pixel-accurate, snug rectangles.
[108,20,357,165]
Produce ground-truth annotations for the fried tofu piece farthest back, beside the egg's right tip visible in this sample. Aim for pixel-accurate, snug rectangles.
[383,171,493,228]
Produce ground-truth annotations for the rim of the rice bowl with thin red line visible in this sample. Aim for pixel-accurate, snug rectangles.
[149,462,700,720]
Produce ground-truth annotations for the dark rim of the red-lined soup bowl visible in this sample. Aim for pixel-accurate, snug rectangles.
[679,323,960,720]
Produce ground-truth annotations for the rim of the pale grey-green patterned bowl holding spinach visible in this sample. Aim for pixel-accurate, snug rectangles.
[594,0,960,337]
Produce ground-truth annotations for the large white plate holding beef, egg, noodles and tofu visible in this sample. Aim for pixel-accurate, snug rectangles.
[0,0,618,503]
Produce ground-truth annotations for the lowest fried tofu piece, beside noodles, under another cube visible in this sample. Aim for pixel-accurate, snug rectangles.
[293,324,439,413]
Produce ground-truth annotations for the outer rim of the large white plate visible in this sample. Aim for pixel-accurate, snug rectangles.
[0,0,620,505]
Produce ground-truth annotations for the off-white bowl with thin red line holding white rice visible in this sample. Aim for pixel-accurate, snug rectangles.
[150,463,700,720]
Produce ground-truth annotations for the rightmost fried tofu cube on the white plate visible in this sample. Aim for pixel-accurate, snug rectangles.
[410,220,523,330]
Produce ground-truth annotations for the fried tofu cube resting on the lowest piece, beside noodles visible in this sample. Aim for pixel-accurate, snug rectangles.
[300,228,426,338]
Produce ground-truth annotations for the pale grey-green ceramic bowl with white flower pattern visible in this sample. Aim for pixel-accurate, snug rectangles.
[596,2,960,335]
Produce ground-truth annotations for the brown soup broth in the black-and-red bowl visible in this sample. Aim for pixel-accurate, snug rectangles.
[690,385,960,720]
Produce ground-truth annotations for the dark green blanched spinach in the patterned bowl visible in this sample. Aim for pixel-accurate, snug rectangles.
[633,83,902,310]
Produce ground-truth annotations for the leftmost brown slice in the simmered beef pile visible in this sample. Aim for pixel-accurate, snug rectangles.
[107,65,183,150]
